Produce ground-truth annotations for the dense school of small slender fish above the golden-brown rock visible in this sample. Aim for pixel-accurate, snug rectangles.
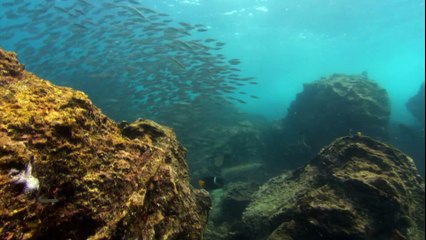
[0,0,258,162]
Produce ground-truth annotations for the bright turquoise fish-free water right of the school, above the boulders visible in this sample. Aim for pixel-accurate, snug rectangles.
[0,0,425,123]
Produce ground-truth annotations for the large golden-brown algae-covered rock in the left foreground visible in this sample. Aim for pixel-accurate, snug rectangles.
[0,49,209,240]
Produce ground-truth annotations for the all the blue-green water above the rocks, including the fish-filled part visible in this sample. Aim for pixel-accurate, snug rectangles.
[0,0,425,174]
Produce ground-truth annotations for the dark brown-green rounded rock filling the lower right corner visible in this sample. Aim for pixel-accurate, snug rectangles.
[243,136,425,240]
